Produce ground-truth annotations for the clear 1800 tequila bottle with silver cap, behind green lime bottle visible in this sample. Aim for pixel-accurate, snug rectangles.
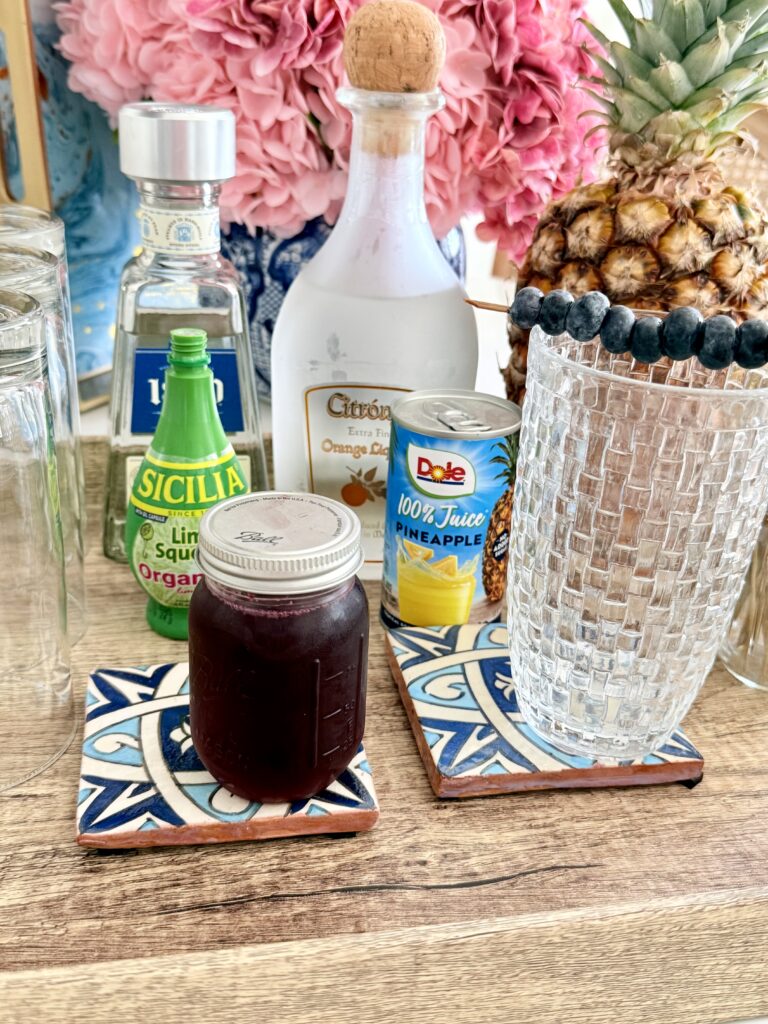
[103,103,266,561]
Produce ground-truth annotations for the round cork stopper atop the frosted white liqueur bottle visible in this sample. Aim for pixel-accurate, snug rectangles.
[344,0,445,92]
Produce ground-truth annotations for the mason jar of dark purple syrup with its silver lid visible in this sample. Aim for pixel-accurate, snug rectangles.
[189,493,369,803]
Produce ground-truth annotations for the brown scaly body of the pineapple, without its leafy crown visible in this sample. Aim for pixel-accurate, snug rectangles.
[503,176,768,403]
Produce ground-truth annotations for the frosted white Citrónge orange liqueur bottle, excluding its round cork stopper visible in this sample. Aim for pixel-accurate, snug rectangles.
[272,88,477,579]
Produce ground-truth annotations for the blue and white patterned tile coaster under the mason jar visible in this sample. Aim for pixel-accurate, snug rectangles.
[77,663,379,848]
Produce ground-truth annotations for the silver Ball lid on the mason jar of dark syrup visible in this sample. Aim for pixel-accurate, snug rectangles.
[198,490,362,596]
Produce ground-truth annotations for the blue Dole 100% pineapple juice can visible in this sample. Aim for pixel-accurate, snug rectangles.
[381,390,520,628]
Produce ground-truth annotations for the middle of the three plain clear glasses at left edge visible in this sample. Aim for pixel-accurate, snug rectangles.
[0,244,86,643]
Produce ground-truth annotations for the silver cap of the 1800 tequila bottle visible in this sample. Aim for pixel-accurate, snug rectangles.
[120,103,234,181]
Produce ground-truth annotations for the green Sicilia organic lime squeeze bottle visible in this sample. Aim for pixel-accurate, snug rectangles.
[125,328,248,640]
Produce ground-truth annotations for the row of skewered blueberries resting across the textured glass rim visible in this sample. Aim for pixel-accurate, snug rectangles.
[508,287,768,371]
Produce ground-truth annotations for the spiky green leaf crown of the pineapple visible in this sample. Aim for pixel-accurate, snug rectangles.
[584,0,768,163]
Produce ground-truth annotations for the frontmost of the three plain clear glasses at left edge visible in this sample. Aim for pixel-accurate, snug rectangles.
[0,291,75,792]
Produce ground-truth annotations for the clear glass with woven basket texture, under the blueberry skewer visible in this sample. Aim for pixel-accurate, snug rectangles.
[508,329,768,763]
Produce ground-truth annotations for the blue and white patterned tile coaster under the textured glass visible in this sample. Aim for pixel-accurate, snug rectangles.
[388,623,703,797]
